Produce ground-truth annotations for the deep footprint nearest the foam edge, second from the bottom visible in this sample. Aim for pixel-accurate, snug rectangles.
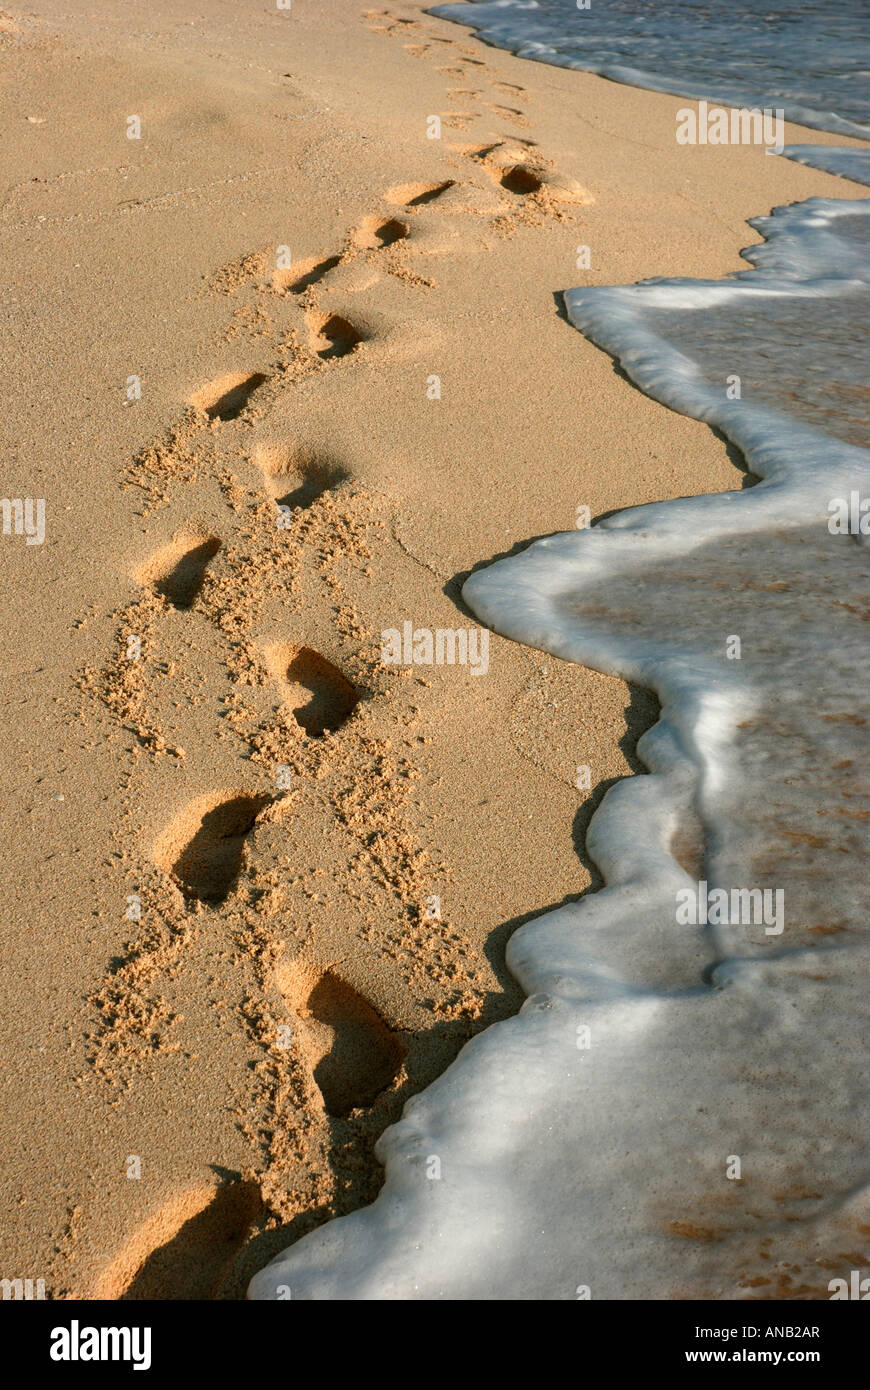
[279,967,406,1118]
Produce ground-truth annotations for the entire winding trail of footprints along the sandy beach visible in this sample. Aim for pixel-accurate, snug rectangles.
[97,11,591,1300]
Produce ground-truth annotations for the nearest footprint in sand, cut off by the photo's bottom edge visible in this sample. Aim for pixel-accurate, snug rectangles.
[93,1182,263,1301]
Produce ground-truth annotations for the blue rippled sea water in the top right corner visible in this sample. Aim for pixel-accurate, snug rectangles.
[431,0,870,138]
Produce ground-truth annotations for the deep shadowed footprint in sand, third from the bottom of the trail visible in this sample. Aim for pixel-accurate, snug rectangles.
[154,791,272,902]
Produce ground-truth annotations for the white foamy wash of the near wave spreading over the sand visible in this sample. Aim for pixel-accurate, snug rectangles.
[250,8,870,1300]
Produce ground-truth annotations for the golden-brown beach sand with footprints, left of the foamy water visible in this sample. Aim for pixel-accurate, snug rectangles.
[0,0,853,1298]
